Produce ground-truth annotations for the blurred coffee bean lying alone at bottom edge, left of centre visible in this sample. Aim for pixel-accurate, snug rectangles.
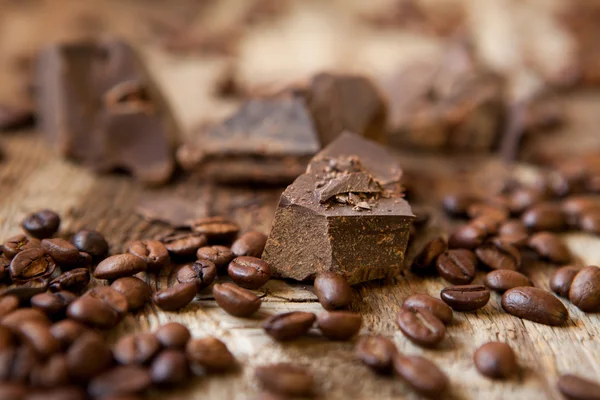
[254,363,314,396]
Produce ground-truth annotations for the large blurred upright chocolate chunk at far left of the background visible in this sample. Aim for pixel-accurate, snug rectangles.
[36,40,174,184]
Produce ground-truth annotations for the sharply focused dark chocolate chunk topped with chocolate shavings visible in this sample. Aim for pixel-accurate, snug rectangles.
[262,132,414,284]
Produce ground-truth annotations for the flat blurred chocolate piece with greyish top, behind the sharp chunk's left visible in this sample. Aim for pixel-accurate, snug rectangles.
[177,94,320,184]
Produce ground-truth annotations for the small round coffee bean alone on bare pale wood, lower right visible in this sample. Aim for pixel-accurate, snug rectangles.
[473,342,519,379]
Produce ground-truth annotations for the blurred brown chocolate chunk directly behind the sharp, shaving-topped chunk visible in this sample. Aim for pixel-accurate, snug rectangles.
[306,73,387,146]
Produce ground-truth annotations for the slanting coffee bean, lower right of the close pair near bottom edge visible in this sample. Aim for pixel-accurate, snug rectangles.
[393,354,450,398]
